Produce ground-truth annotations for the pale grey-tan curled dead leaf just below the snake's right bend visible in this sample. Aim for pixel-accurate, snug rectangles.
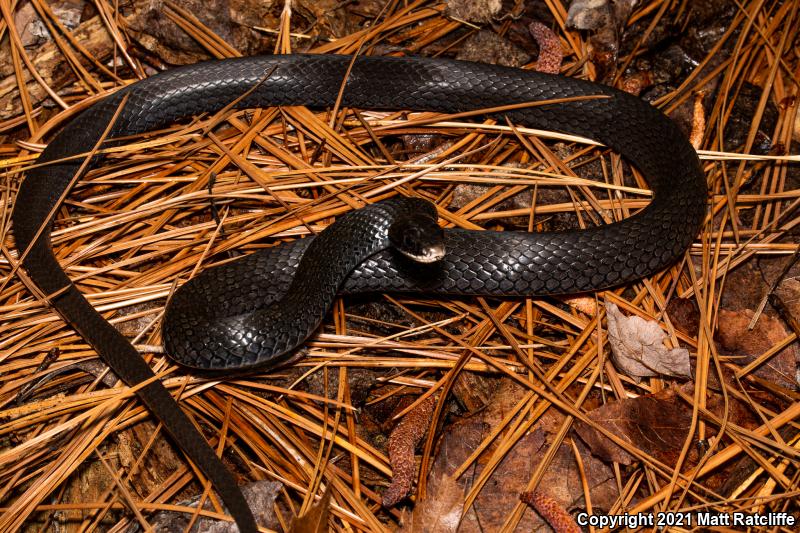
[606,302,691,378]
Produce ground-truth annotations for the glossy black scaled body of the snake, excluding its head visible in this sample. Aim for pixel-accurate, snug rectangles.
[12,55,706,531]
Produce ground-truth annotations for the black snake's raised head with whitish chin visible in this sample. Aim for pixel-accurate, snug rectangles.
[389,213,445,263]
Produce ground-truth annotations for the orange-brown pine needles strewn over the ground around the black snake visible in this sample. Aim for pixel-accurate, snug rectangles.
[0,0,800,531]
